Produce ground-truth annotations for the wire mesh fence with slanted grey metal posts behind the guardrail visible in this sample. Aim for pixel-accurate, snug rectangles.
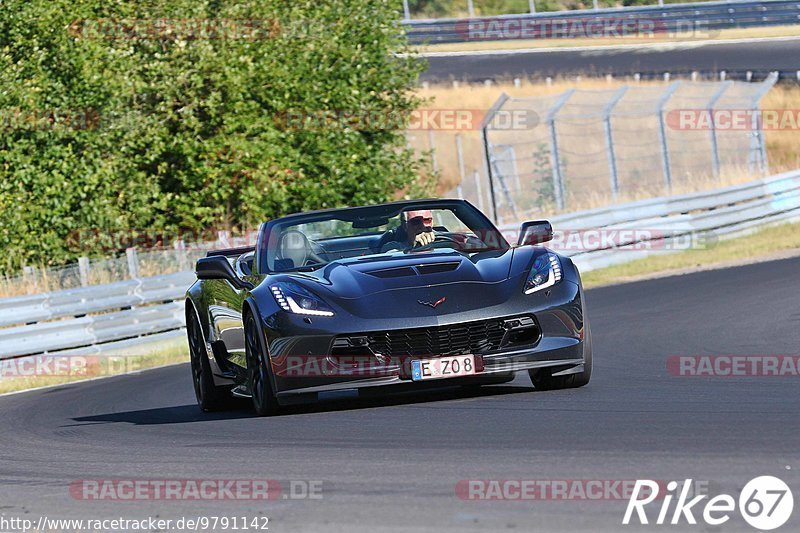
[439,73,777,223]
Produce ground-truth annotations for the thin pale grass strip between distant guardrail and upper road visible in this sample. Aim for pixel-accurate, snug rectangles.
[417,25,798,53]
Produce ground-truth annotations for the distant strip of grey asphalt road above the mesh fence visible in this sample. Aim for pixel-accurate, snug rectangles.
[421,37,800,81]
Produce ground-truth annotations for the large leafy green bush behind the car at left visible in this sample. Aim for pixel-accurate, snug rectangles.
[0,0,428,272]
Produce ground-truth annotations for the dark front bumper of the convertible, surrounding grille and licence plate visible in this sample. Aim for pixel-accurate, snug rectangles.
[264,280,591,403]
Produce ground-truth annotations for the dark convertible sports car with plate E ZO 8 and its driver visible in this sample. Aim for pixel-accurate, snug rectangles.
[186,200,592,415]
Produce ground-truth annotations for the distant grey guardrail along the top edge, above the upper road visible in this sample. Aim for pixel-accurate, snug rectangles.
[403,0,800,44]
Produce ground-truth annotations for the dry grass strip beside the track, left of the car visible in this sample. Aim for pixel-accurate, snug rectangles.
[0,338,189,394]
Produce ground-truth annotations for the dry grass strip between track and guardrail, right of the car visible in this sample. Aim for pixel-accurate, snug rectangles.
[581,219,800,288]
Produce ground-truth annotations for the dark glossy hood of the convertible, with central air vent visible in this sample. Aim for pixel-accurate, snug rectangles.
[274,249,527,317]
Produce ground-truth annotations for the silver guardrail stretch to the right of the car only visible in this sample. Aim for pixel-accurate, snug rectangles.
[501,171,800,272]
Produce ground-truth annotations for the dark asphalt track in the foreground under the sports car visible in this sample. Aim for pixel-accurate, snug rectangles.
[0,258,800,532]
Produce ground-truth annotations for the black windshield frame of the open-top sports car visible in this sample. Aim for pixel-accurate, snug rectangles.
[253,199,511,275]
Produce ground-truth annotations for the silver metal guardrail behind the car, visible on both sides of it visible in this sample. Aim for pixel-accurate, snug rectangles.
[0,171,800,359]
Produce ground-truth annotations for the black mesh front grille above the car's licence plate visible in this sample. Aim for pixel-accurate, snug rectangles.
[335,317,539,357]
